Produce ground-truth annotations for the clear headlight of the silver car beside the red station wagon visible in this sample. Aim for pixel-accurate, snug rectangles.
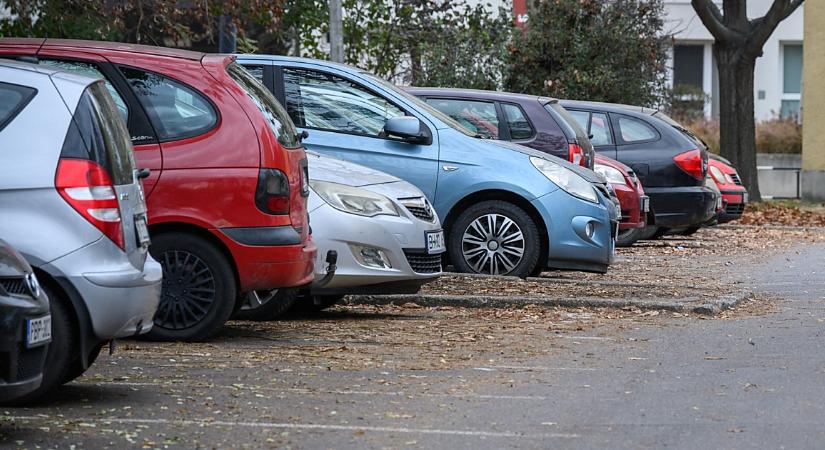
[309,181,398,217]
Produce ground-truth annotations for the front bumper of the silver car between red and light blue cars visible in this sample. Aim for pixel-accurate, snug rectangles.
[311,204,441,295]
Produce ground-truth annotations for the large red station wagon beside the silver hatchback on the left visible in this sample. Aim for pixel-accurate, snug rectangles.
[0,39,316,340]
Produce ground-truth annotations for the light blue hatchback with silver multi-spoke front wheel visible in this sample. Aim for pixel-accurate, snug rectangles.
[238,55,618,277]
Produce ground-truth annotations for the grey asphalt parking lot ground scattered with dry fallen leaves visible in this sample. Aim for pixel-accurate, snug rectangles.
[0,228,825,449]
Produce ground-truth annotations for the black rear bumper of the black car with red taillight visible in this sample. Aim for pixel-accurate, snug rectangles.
[645,186,717,228]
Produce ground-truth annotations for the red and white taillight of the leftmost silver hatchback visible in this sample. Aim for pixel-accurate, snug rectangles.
[54,158,125,248]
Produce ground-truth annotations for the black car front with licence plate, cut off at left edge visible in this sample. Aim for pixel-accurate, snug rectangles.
[0,239,52,403]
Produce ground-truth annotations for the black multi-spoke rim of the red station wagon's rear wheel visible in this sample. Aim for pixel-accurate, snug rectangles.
[154,250,215,330]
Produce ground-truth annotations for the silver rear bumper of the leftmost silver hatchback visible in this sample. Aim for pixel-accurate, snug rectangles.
[43,239,163,340]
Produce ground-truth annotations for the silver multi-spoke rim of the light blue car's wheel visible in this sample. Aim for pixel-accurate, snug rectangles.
[461,214,525,275]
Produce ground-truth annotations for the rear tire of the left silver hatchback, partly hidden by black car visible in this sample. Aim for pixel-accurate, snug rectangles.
[4,285,80,406]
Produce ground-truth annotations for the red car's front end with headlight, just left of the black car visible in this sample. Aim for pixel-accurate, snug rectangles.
[593,154,650,247]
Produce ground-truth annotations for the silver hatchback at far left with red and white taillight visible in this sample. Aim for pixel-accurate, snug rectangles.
[0,61,162,399]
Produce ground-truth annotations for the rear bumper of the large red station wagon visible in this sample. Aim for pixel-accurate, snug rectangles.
[219,224,318,292]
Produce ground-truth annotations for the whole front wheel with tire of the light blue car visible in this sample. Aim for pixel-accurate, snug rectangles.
[447,200,541,278]
